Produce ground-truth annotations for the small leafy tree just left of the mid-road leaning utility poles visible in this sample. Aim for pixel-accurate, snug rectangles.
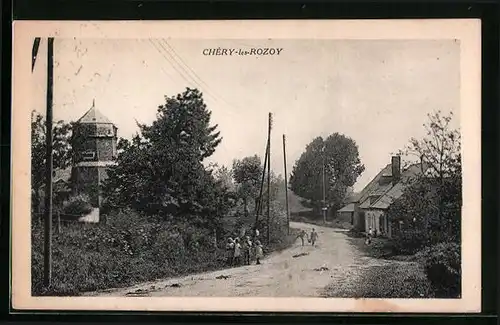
[233,155,263,216]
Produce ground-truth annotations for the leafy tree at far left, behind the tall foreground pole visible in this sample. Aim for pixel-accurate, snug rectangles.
[31,111,72,214]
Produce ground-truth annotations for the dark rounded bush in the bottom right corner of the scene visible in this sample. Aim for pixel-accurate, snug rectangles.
[417,242,461,298]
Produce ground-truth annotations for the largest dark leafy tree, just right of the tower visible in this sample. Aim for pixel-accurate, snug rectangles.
[104,88,227,229]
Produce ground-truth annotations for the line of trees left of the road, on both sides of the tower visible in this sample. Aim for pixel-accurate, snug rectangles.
[32,88,283,235]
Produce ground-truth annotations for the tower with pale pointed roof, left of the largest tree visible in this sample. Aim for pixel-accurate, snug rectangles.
[71,101,118,208]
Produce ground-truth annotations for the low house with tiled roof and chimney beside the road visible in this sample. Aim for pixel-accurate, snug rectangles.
[340,156,424,237]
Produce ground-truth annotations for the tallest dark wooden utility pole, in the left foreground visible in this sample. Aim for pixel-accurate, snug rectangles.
[43,37,54,287]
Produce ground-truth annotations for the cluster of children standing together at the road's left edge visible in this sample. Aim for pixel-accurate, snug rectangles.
[226,230,264,266]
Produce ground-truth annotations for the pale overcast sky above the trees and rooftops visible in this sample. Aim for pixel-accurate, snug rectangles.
[33,39,460,191]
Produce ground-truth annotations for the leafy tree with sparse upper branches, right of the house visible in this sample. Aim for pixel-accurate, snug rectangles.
[388,111,462,246]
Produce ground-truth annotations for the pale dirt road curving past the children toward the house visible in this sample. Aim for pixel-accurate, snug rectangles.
[88,222,404,297]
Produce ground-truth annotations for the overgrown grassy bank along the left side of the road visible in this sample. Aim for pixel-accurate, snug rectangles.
[32,220,296,296]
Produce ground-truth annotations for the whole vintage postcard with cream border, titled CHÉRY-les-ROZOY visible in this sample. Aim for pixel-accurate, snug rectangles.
[12,20,481,313]
